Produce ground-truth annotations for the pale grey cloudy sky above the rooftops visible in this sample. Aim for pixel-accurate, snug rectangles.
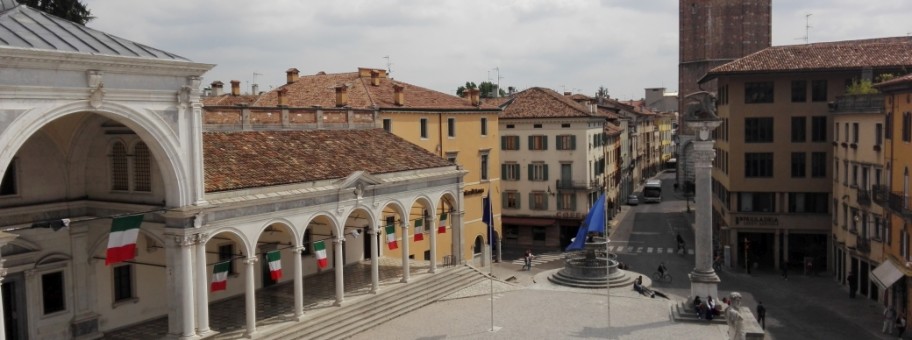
[83,0,912,99]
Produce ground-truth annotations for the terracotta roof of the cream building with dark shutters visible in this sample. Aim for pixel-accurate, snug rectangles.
[500,87,593,119]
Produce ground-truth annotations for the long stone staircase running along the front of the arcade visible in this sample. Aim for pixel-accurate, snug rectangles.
[255,265,486,339]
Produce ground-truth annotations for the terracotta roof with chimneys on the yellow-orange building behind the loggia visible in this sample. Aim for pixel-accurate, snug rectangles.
[239,69,497,110]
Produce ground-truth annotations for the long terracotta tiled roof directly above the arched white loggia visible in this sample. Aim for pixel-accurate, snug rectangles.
[203,129,452,192]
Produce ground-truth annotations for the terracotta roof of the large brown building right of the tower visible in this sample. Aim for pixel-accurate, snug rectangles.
[700,37,912,82]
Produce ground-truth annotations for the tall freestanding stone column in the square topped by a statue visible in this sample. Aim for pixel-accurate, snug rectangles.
[688,121,721,298]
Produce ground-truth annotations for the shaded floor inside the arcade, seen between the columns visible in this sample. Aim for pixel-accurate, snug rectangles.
[104,257,438,340]
